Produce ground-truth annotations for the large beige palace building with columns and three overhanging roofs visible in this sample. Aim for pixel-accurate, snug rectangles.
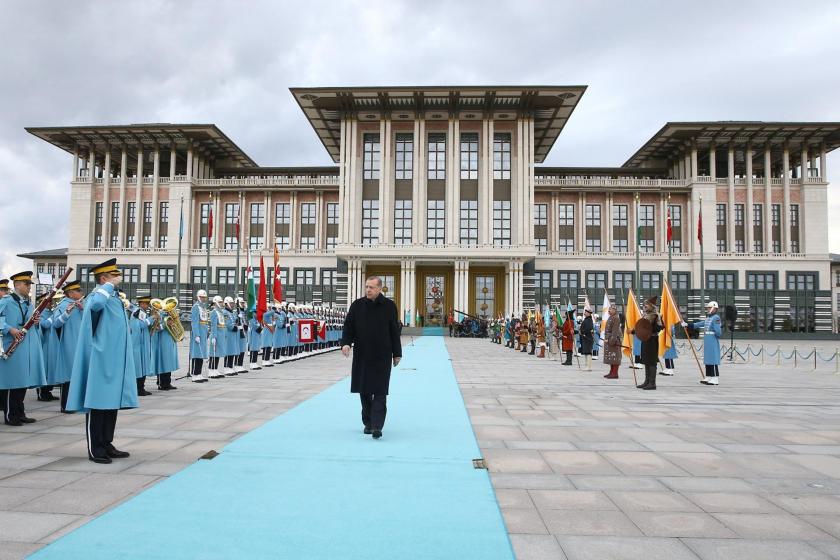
[27,86,840,332]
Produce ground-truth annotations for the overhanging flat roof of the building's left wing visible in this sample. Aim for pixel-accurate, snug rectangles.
[26,123,257,167]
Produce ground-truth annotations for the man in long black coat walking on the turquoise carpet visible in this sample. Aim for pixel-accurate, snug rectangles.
[341,276,402,439]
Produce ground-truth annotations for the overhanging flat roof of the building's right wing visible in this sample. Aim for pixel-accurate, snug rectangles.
[624,121,840,167]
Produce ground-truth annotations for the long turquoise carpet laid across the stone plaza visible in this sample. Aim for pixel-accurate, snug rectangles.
[30,337,513,560]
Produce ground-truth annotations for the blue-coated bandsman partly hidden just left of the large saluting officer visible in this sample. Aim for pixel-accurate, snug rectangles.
[47,278,84,412]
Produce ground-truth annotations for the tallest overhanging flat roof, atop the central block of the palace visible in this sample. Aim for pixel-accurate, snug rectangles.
[290,86,586,163]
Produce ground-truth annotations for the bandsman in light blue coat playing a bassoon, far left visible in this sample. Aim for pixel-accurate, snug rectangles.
[0,271,47,426]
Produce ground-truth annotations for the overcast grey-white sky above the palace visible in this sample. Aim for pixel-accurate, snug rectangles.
[0,0,840,275]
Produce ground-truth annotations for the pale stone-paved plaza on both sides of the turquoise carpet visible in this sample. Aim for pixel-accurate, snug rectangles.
[0,338,840,560]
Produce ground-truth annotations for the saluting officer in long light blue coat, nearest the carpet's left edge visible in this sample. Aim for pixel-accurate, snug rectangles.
[67,259,138,463]
